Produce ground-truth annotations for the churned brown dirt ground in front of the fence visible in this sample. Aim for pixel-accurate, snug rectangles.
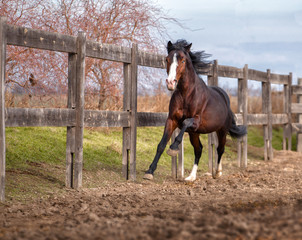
[0,151,302,240]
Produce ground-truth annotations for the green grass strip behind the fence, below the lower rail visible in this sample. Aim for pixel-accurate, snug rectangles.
[2,124,295,201]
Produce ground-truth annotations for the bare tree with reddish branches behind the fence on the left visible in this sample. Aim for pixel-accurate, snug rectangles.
[0,0,177,109]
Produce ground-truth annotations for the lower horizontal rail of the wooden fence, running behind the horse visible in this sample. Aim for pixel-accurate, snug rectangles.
[5,109,290,127]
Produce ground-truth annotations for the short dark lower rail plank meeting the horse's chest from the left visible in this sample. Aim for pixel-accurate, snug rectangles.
[137,112,168,127]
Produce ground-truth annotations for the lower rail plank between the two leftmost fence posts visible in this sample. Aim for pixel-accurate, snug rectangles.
[5,108,75,127]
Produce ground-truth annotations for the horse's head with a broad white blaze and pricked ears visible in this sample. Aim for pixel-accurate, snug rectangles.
[166,41,192,91]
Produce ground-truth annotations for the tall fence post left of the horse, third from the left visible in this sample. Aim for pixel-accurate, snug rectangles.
[129,43,138,181]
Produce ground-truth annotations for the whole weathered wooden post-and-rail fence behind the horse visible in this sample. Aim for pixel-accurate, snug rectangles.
[0,17,302,201]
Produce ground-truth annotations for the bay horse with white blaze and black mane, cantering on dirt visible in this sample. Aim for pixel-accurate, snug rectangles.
[144,40,247,181]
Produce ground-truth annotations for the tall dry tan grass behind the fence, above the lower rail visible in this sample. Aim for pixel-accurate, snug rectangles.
[5,89,288,114]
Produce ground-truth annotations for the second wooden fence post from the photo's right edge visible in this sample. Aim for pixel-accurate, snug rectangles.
[283,73,292,150]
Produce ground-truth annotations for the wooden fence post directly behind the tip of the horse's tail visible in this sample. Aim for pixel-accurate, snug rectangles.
[237,64,248,168]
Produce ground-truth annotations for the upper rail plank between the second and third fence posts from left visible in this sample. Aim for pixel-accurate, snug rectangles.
[86,40,131,63]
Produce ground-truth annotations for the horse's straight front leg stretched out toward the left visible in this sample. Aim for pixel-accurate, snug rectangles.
[144,118,177,180]
